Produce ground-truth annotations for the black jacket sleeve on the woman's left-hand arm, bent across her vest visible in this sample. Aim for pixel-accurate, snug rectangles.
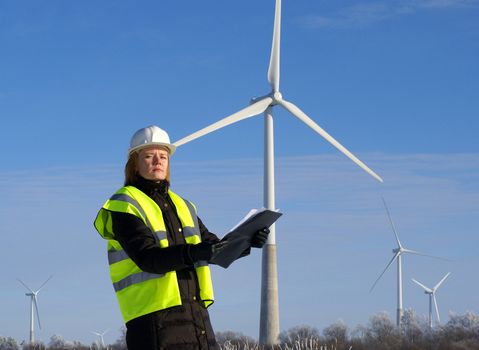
[111,212,192,273]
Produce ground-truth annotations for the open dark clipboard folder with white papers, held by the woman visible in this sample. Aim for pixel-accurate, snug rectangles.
[210,208,283,268]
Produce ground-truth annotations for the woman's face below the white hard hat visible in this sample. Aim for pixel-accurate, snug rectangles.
[136,146,169,181]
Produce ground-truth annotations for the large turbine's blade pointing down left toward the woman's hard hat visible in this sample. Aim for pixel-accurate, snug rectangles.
[173,97,273,147]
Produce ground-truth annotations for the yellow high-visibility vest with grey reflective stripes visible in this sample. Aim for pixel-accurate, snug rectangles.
[95,186,214,323]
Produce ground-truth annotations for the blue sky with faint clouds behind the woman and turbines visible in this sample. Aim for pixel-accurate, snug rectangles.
[0,0,479,343]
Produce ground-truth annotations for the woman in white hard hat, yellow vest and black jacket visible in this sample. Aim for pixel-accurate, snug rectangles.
[95,126,269,350]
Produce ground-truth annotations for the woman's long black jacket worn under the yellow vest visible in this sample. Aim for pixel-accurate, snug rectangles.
[112,178,219,350]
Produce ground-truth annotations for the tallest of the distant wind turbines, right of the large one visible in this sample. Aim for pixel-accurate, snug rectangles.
[369,198,445,327]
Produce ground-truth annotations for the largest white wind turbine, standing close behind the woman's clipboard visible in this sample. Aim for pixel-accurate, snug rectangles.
[174,0,382,345]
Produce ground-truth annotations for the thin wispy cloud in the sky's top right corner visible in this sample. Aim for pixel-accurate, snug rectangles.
[300,0,479,29]
